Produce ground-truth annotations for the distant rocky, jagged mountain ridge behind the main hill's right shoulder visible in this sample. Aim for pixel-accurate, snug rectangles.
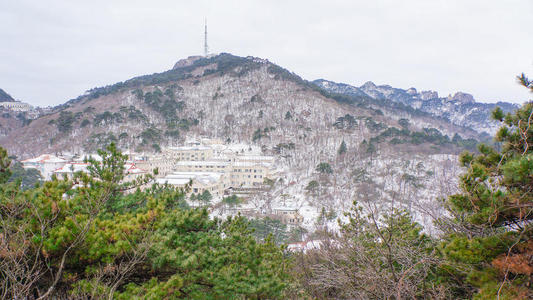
[314,79,518,135]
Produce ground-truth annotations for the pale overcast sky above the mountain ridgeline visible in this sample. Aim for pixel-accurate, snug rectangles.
[0,0,533,106]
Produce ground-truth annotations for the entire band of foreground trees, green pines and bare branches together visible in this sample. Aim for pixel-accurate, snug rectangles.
[0,75,533,299]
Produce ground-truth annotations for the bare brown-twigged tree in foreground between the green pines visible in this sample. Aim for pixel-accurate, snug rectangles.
[295,200,448,299]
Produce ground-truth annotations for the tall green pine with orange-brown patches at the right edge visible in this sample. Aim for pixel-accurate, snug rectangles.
[441,74,533,299]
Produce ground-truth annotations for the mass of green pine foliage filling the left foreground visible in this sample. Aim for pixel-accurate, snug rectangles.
[0,145,289,299]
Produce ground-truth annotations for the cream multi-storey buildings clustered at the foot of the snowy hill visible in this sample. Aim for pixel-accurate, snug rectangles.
[22,139,303,226]
